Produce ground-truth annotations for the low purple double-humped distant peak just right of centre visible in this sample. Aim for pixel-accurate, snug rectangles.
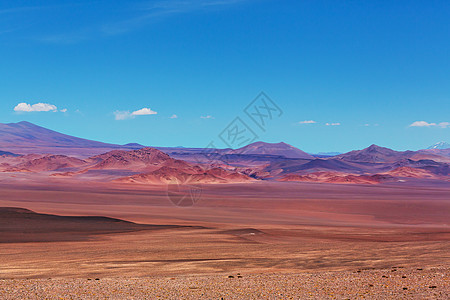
[229,142,314,159]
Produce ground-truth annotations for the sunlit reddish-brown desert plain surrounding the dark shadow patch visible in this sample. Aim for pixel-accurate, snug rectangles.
[0,178,450,299]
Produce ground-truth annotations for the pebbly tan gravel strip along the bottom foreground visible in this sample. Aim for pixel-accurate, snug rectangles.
[0,266,450,299]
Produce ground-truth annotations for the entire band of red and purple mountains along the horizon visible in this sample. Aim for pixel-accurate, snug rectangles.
[0,122,450,184]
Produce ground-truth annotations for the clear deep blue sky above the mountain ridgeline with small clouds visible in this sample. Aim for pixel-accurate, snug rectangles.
[0,0,450,152]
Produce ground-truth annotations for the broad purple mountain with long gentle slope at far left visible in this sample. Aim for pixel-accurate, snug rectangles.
[0,121,142,156]
